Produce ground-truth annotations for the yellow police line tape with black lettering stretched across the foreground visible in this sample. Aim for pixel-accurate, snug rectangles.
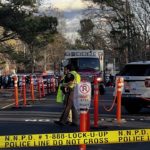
[0,129,150,148]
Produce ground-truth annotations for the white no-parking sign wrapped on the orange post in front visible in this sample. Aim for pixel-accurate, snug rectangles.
[73,82,91,111]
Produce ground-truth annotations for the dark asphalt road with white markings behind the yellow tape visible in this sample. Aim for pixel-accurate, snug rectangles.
[0,88,150,150]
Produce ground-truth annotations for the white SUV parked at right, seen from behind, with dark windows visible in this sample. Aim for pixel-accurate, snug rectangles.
[115,61,150,113]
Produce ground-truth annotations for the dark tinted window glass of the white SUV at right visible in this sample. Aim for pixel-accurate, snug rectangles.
[119,64,150,76]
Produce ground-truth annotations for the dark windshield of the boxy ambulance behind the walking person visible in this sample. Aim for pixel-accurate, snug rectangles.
[71,58,100,71]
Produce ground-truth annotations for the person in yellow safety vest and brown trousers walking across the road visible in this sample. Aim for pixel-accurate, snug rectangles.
[55,65,81,126]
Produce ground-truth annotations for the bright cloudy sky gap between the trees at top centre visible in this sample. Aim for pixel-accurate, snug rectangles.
[39,0,87,41]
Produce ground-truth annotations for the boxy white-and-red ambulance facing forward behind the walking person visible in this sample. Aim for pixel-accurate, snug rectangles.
[62,50,105,95]
